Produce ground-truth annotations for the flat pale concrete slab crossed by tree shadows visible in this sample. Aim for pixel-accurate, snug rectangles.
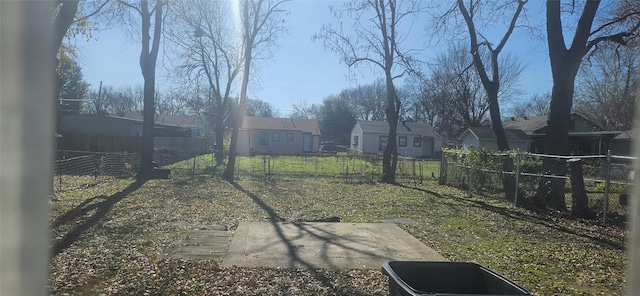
[222,222,446,269]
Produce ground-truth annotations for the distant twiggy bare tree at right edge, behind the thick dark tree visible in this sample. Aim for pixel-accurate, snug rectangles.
[574,45,640,131]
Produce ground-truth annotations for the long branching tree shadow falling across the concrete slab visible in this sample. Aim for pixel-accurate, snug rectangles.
[231,182,380,296]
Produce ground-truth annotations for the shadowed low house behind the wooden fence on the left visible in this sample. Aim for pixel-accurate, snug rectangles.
[60,114,192,137]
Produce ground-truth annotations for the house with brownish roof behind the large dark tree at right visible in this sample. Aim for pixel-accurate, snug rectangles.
[502,113,620,155]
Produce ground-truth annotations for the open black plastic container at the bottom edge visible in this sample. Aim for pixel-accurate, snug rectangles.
[382,261,531,296]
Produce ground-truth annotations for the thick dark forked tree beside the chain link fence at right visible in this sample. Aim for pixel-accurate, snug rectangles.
[534,0,640,211]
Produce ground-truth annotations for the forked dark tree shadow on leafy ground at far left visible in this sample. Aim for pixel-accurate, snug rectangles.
[51,180,145,257]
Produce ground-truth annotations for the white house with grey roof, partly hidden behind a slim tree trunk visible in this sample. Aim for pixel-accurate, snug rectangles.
[349,121,442,157]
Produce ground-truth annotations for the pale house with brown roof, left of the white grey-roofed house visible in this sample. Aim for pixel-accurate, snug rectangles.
[236,116,320,155]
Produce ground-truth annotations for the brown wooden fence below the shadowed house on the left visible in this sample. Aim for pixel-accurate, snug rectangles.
[57,135,215,153]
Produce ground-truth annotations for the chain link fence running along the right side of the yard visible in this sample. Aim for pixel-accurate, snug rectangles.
[439,149,635,223]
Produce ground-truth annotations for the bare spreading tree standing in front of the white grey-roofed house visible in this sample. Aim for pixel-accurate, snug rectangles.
[314,0,421,183]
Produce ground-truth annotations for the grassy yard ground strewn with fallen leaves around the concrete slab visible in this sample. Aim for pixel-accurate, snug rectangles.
[50,176,627,295]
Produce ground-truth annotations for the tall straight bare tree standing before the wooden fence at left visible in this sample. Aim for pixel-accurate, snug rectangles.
[118,0,165,180]
